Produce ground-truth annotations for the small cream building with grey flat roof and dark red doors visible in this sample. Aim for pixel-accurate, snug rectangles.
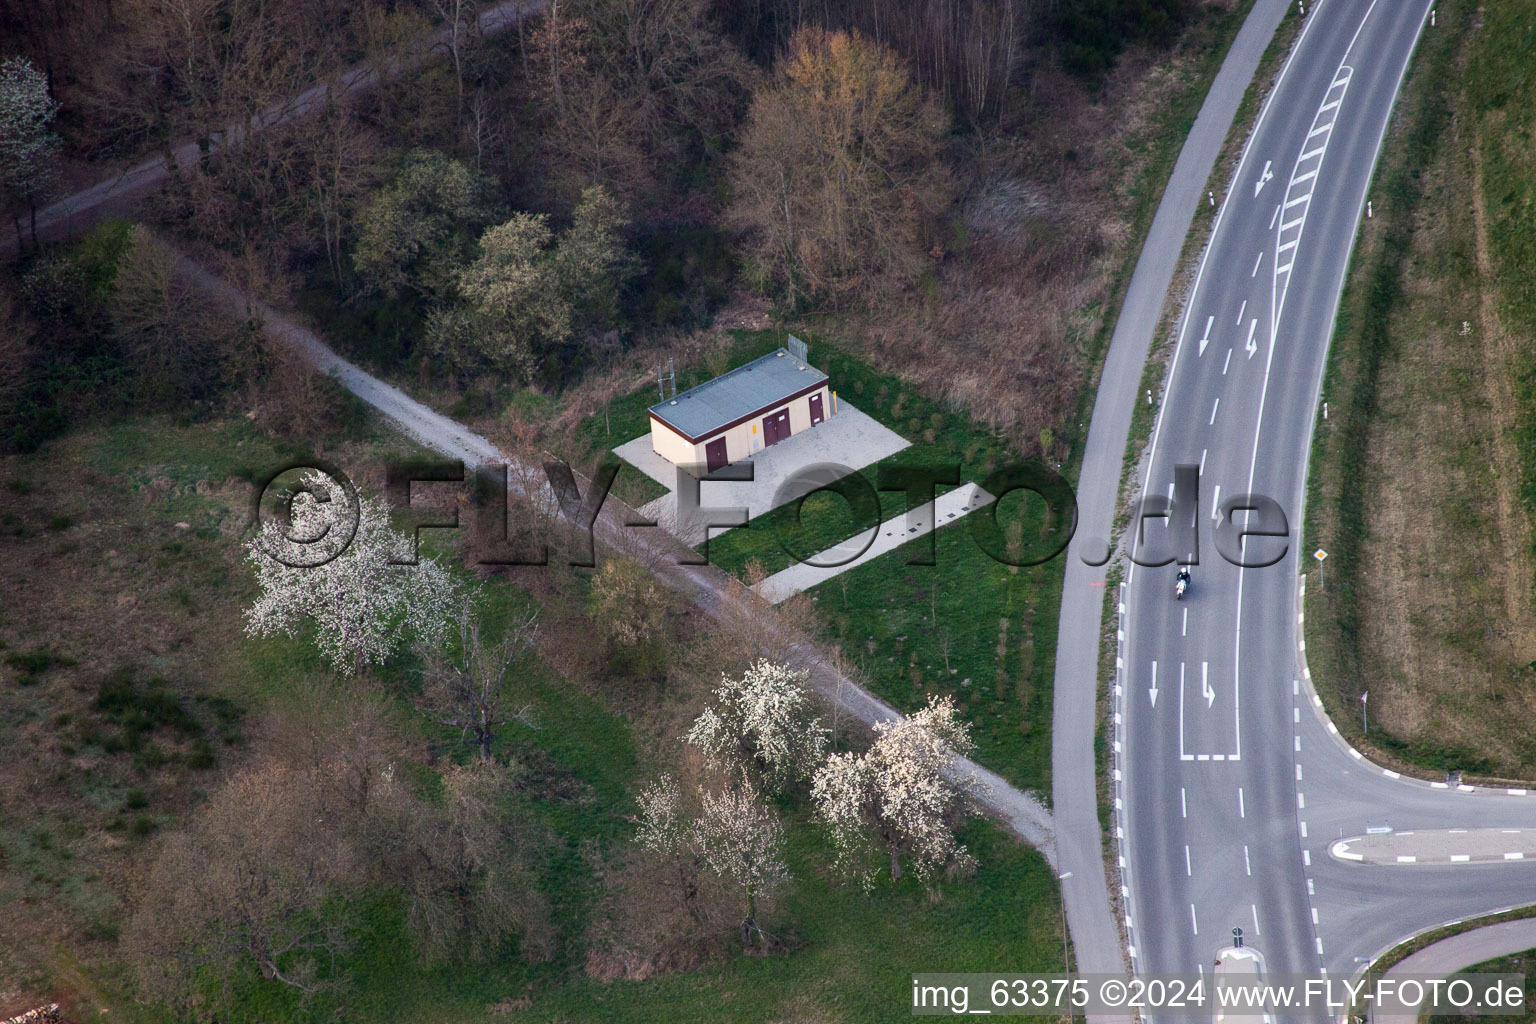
[650,342,831,473]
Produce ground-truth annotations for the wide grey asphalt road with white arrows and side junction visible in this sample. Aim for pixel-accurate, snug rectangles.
[1118,0,1536,1013]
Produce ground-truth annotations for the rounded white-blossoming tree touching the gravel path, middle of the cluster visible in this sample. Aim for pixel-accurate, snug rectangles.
[685,660,828,792]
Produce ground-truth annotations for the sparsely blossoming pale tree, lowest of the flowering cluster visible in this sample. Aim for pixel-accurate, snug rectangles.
[637,775,790,946]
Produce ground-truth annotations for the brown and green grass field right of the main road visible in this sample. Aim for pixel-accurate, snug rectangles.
[1306,3,1536,778]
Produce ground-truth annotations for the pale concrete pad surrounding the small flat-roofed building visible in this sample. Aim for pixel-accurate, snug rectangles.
[613,398,911,545]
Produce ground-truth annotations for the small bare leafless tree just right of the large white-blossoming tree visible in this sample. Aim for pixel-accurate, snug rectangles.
[416,602,539,761]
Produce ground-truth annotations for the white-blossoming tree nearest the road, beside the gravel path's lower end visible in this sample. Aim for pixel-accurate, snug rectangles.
[811,697,982,887]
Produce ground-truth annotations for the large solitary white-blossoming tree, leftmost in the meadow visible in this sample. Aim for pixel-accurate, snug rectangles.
[246,473,461,674]
